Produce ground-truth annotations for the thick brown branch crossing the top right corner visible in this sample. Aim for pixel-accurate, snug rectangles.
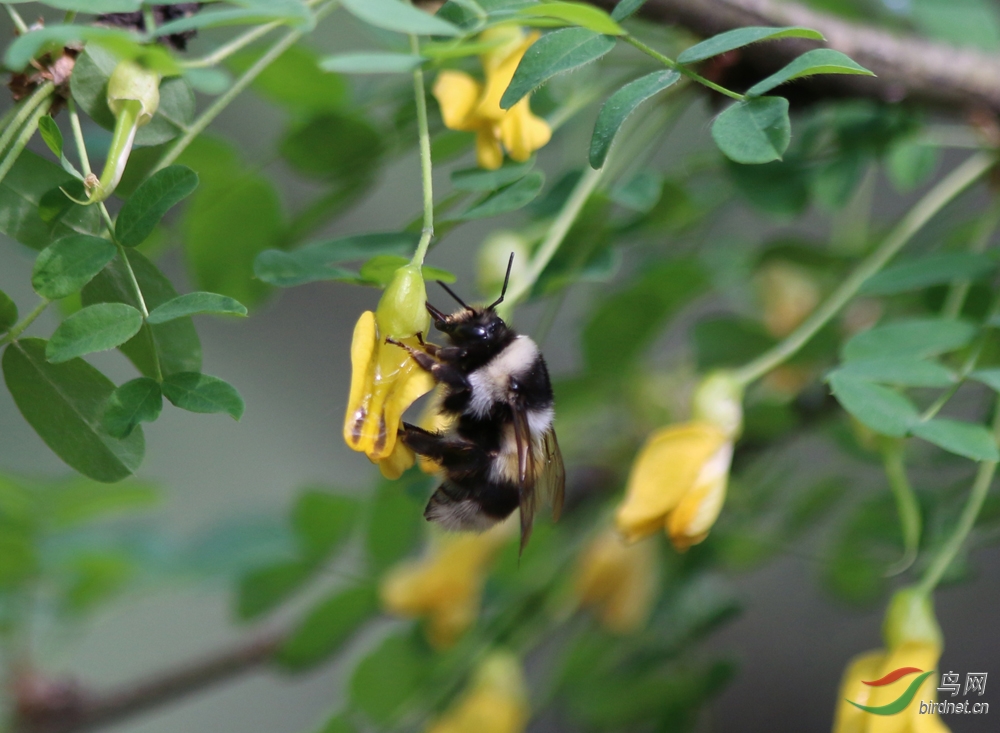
[589,0,1000,114]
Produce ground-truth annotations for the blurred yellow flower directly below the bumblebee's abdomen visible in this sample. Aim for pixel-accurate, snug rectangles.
[380,522,514,648]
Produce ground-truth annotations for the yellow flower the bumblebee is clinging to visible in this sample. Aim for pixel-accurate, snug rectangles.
[344,265,434,478]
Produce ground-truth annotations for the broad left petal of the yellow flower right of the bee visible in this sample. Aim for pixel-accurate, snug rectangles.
[615,422,727,541]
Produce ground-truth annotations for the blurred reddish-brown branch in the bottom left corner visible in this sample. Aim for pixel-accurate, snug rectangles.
[11,632,285,733]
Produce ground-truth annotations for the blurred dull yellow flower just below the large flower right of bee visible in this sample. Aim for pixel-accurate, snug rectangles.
[576,530,660,634]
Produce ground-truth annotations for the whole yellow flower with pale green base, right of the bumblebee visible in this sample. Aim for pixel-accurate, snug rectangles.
[615,372,743,551]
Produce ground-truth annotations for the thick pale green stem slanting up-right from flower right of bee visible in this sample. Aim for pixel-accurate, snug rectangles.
[733,153,996,386]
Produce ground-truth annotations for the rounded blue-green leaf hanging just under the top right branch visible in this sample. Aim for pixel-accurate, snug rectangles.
[712,97,792,164]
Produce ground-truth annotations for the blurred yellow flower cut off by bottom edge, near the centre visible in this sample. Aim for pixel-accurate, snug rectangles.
[427,652,529,733]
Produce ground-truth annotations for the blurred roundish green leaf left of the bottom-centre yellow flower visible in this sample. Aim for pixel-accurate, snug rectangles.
[350,635,429,726]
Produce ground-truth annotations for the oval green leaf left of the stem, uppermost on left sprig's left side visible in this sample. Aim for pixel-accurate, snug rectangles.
[31,234,118,300]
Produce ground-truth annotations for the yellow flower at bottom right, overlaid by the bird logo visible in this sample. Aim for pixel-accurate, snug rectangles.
[833,589,949,733]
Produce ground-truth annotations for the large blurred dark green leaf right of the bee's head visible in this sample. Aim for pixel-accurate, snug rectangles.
[583,260,708,378]
